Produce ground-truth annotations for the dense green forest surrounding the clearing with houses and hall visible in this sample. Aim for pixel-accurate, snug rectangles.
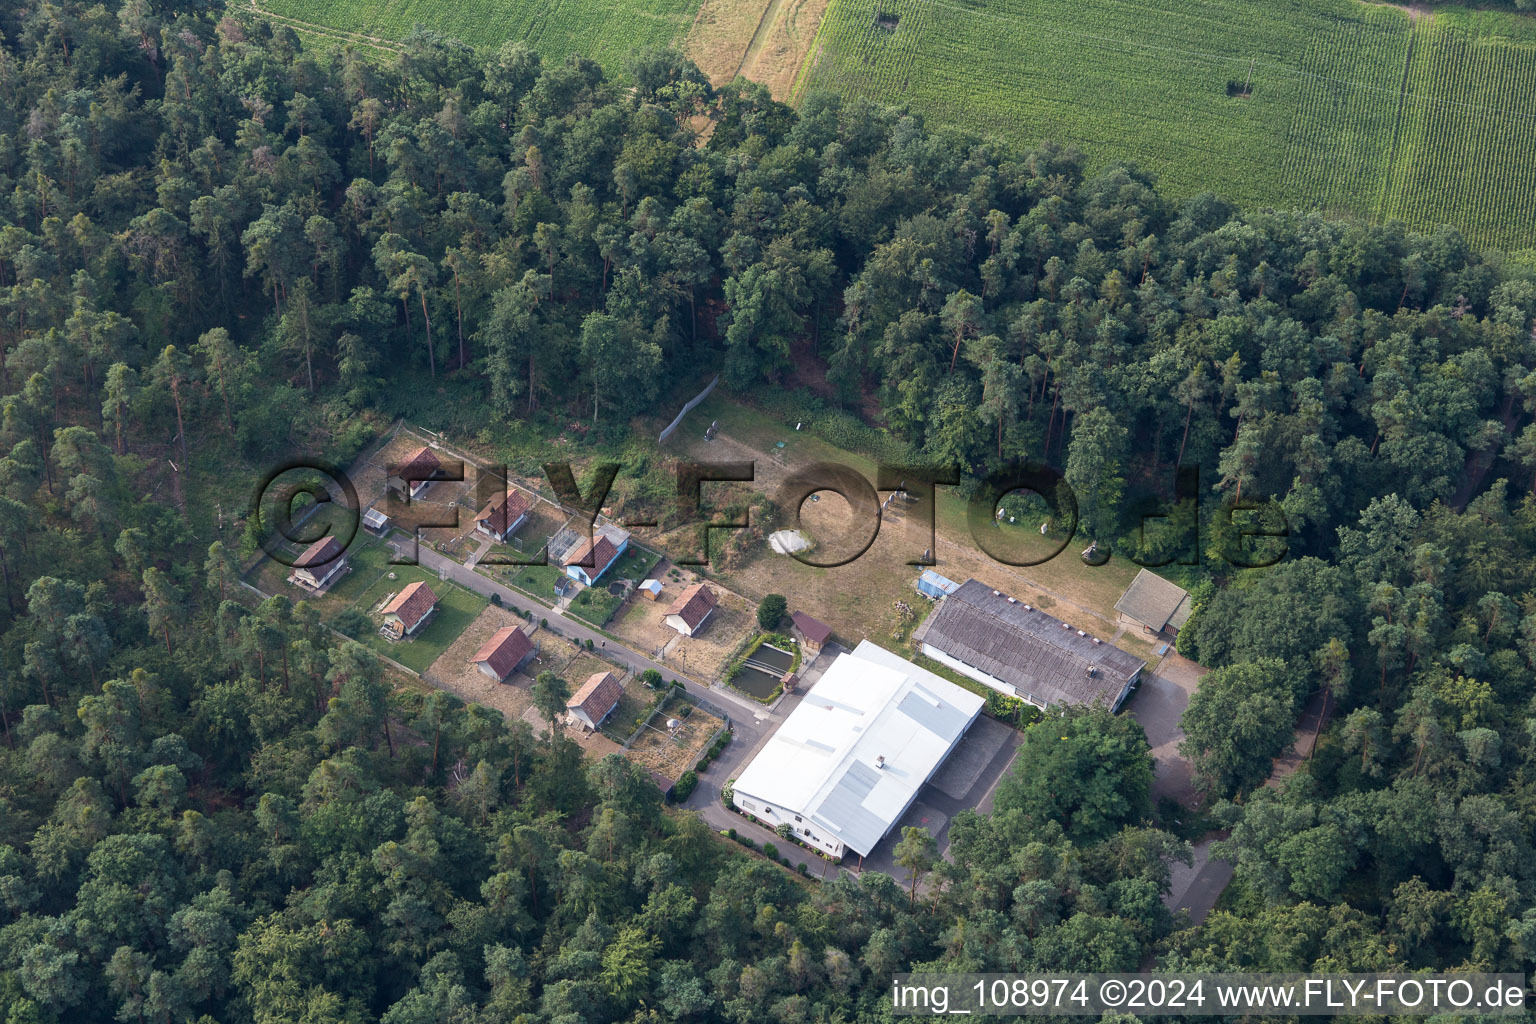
[0,0,1536,1024]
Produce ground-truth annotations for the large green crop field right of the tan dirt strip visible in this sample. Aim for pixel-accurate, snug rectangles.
[796,0,1536,249]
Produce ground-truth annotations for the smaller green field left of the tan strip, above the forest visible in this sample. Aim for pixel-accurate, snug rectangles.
[250,0,699,71]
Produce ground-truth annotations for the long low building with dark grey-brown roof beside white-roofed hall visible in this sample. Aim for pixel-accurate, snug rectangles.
[915,579,1146,711]
